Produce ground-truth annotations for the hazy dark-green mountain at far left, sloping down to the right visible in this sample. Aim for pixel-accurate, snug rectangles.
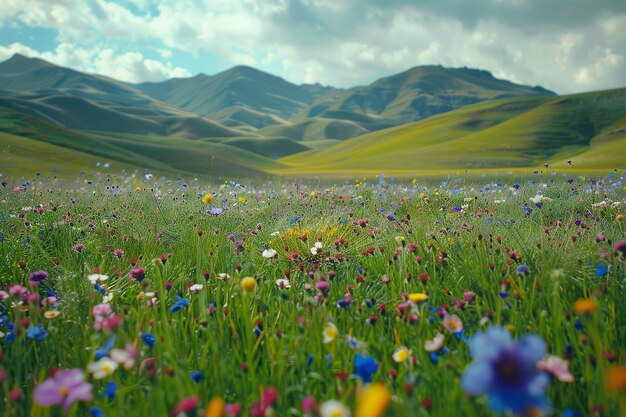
[0,54,249,138]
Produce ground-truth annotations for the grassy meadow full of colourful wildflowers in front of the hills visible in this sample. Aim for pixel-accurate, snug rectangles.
[0,169,626,417]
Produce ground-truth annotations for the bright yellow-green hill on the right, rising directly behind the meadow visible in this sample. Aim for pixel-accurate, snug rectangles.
[277,88,626,174]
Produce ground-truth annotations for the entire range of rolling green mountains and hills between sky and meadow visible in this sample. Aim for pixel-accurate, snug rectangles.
[0,54,626,175]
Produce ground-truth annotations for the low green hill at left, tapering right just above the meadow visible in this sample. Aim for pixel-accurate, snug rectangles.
[0,110,280,177]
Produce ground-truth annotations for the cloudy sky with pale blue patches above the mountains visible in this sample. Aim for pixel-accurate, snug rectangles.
[0,0,626,94]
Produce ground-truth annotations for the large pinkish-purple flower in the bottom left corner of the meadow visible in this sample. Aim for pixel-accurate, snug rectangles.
[33,369,93,413]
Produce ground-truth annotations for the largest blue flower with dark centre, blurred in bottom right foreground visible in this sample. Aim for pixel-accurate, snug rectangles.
[461,326,550,413]
